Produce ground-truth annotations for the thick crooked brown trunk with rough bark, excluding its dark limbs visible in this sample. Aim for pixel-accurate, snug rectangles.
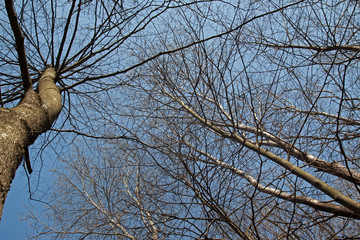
[0,68,61,219]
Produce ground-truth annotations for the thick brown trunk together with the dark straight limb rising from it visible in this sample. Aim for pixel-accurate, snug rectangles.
[0,1,61,219]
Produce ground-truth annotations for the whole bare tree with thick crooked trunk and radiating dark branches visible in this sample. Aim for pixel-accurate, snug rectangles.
[0,0,197,219]
